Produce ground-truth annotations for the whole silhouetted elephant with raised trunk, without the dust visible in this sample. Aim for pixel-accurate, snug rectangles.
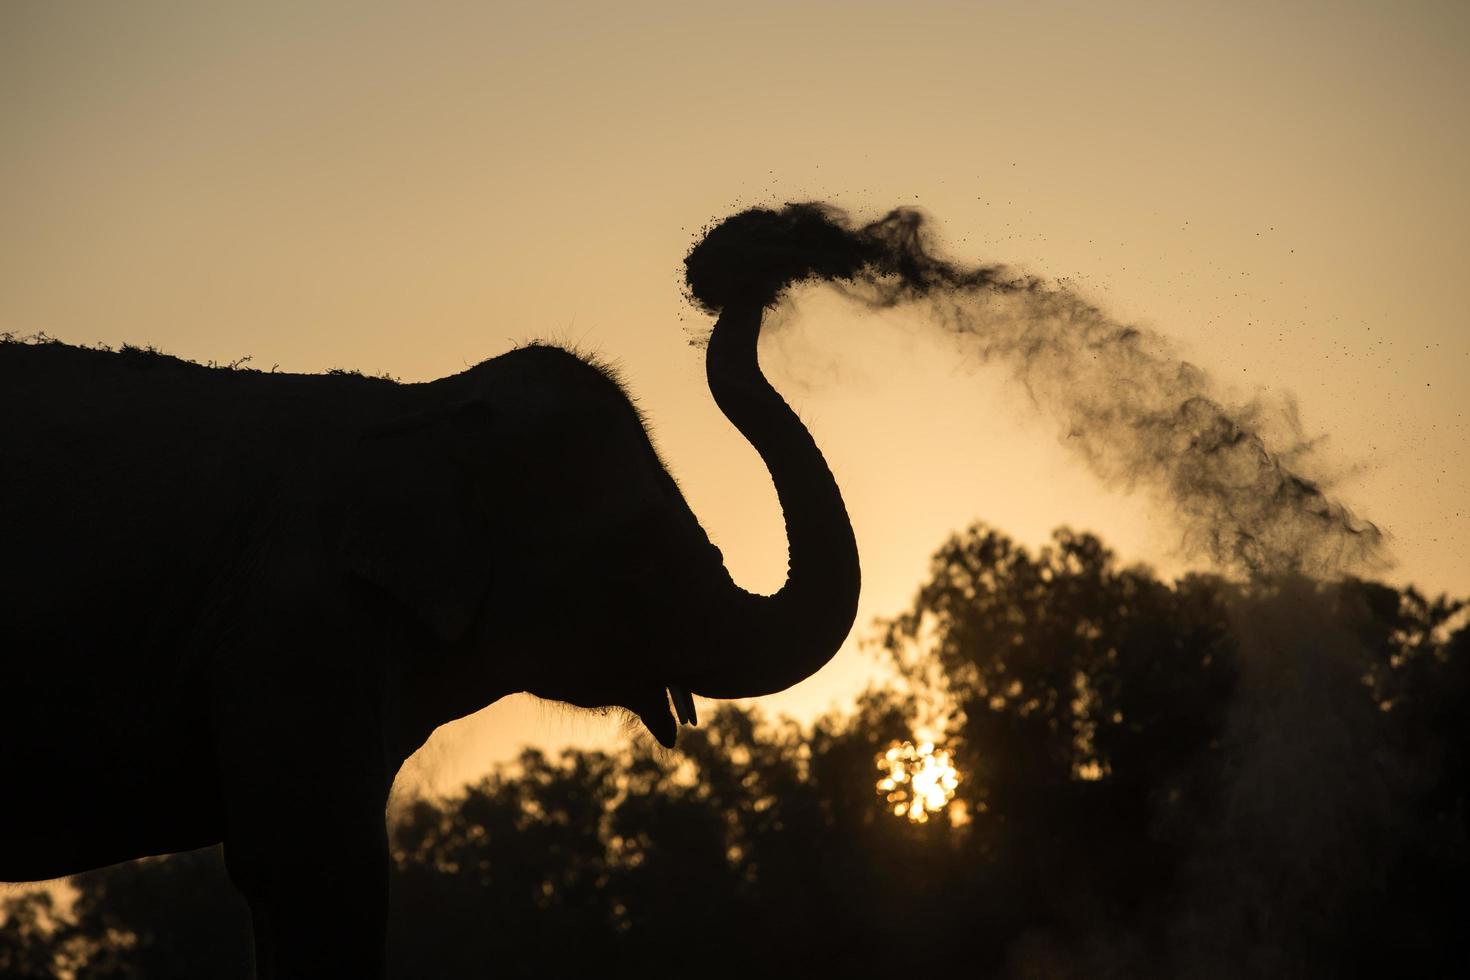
[0,297,860,979]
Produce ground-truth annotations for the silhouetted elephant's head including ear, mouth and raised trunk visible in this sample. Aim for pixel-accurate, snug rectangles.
[336,303,860,745]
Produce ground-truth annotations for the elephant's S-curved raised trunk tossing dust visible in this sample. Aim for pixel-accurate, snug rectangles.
[689,304,861,698]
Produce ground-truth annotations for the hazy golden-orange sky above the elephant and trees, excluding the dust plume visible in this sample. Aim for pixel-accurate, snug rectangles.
[0,0,1470,786]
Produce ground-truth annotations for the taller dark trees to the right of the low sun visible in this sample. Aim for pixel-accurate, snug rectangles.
[882,526,1470,976]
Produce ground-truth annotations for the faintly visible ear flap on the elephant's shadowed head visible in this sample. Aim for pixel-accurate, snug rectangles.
[341,403,491,642]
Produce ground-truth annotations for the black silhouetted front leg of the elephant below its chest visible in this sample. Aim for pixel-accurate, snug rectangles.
[215,620,392,980]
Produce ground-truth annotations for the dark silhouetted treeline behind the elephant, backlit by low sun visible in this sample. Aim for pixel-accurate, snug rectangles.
[0,526,1470,979]
